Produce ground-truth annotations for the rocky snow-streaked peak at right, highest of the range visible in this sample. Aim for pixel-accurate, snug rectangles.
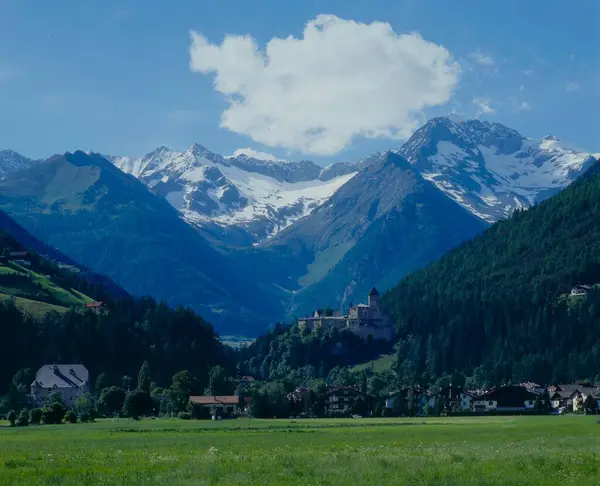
[397,117,596,223]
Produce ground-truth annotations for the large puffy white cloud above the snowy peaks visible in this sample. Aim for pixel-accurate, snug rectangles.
[190,15,459,155]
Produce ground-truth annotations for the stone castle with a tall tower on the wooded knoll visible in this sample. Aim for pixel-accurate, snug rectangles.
[298,287,394,341]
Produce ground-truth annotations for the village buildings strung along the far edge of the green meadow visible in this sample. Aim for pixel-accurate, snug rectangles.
[25,364,600,420]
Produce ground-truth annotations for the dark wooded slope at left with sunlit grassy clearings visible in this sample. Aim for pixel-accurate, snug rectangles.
[0,215,232,396]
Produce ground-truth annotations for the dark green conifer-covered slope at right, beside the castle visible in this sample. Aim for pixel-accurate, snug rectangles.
[383,159,600,382]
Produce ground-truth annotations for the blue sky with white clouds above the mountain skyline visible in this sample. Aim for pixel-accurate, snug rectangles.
[0,0,600,164]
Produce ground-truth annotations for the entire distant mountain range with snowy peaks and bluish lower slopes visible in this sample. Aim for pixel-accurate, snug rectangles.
[0,117,596,333]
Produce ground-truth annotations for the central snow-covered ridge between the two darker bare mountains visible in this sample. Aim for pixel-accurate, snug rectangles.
[107,144,358,244]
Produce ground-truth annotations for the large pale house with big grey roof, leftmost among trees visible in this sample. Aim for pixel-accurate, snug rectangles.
[31,364,90,407]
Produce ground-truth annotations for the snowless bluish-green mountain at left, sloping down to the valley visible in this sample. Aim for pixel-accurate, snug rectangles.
[0,152,281,332]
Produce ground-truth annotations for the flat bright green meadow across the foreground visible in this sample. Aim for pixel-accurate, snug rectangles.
[0,416,600,486]
